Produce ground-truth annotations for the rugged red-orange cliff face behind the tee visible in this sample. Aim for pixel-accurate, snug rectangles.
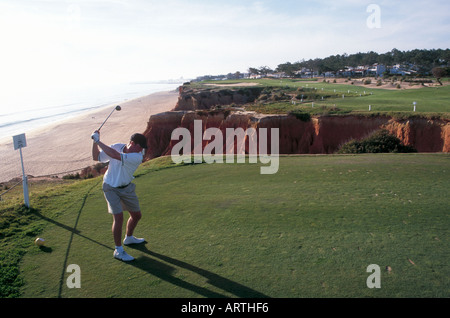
[144,111,450,159]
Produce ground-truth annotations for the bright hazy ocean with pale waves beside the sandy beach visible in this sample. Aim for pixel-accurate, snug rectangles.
[0,82,181,139]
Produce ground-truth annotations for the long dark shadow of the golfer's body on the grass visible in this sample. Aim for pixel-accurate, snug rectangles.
[129,244,269,298]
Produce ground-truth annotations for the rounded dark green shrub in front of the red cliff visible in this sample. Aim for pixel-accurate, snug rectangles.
[338,129,417,154]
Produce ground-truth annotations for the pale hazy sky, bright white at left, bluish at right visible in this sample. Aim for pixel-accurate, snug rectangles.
[0,0,450,90]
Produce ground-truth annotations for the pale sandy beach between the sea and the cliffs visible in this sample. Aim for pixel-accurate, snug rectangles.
[0,91,178,182]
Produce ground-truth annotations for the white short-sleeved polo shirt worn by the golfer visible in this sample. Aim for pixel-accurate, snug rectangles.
[98,144,144,188]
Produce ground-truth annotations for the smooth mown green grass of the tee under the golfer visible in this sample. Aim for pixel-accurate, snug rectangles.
[0,154,450,298]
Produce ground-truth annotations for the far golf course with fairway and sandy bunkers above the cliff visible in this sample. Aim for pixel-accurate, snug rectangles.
[207,78,450,118]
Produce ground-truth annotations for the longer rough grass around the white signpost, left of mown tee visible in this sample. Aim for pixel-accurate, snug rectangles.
[0,181,85,297]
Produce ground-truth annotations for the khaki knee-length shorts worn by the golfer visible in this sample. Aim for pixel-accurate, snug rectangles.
[103,183,141,214]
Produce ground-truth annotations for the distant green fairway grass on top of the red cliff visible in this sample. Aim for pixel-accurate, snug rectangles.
[200,79,450,118]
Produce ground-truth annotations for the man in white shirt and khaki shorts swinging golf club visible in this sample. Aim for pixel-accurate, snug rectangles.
[91,130,147,262]
